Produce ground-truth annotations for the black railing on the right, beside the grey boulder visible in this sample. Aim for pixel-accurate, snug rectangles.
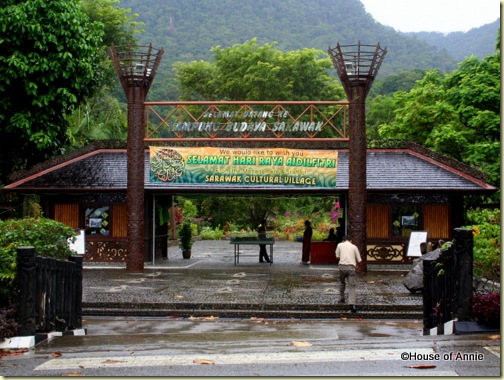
[423,228,473,335]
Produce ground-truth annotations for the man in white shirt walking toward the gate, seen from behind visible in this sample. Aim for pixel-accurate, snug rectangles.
[336,235,362,313]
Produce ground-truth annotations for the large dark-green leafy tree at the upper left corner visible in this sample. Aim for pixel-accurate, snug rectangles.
[0,0,103,183]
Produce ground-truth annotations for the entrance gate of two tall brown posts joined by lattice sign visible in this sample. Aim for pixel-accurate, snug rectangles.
[110,42,386,270]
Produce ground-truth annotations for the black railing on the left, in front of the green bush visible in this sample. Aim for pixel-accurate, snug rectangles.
[17,247,82,336]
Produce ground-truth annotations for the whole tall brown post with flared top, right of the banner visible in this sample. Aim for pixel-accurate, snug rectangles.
[328,42,387,272]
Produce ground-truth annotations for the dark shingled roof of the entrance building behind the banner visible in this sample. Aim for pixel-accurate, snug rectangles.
[5,150,494,192]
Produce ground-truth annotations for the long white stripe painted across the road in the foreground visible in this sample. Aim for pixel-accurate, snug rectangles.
[35,348,434,375]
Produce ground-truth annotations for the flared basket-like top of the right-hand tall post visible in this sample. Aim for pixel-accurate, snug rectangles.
[328,42,387,94]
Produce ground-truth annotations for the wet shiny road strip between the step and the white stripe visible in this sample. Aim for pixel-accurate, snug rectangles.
[37,317,422,354]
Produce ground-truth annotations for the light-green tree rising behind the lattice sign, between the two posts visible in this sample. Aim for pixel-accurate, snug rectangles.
[174,38,344,100]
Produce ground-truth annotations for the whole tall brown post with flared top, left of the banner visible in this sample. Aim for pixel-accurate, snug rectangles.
[110,45,164,270]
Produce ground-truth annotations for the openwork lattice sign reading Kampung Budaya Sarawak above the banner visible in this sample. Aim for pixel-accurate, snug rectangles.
[145,101,349,141]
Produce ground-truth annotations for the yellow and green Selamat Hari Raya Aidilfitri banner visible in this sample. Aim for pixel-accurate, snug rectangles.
[150,146,338,188]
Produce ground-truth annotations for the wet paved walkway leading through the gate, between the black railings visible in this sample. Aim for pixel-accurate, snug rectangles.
[83,241,422,319]
